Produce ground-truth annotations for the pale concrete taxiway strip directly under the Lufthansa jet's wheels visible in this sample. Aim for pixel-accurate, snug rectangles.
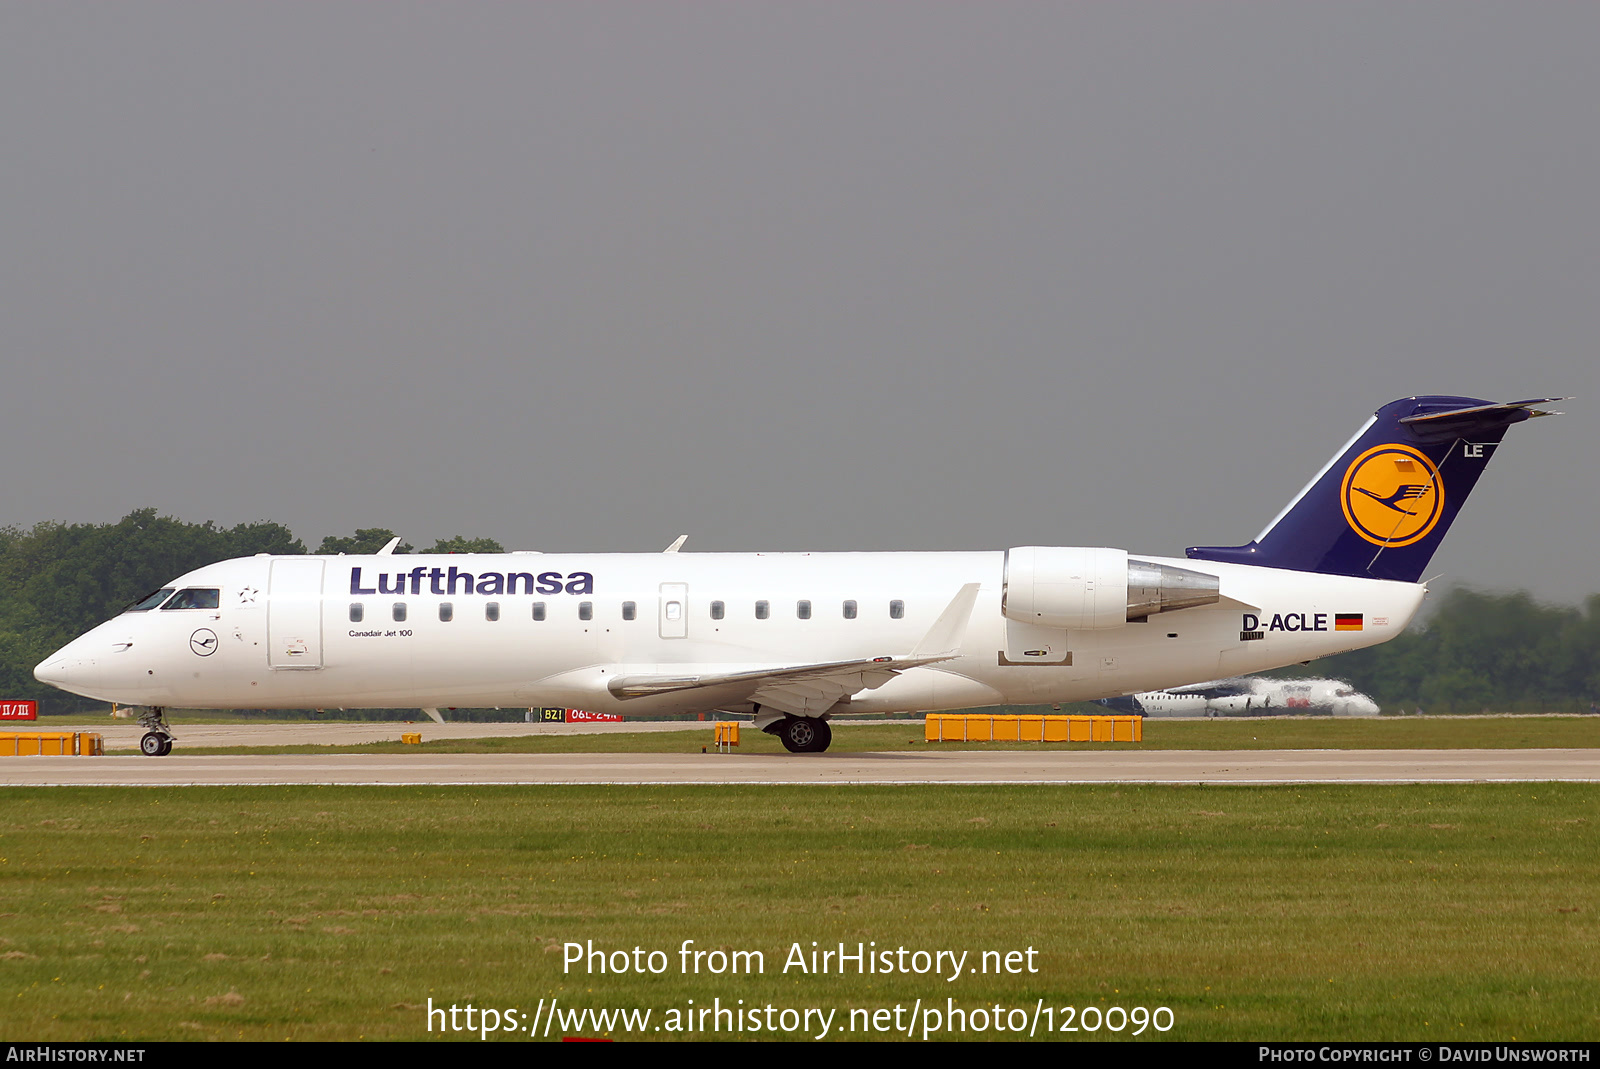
[0,747,1600,786]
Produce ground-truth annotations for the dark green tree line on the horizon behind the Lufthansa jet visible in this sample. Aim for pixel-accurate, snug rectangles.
[0,509,1600,712]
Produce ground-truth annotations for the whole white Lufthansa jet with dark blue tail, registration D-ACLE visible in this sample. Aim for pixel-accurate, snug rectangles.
[34,395,1557,755]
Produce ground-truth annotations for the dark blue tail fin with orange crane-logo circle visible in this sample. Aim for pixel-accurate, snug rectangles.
[1187,397,1563,583]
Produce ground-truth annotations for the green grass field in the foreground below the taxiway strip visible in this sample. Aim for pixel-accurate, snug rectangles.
[0,780,1600,1042]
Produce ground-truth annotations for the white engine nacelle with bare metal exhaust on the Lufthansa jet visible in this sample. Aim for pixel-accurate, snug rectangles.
[1000,546,1221,631]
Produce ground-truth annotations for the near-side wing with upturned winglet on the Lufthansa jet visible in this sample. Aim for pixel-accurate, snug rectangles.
[606,583,979,717]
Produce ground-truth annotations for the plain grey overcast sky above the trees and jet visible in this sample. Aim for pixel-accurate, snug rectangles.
[0,0,1600,602]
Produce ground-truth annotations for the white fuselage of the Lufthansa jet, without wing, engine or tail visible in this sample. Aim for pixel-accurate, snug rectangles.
[38,552,1424,715]
